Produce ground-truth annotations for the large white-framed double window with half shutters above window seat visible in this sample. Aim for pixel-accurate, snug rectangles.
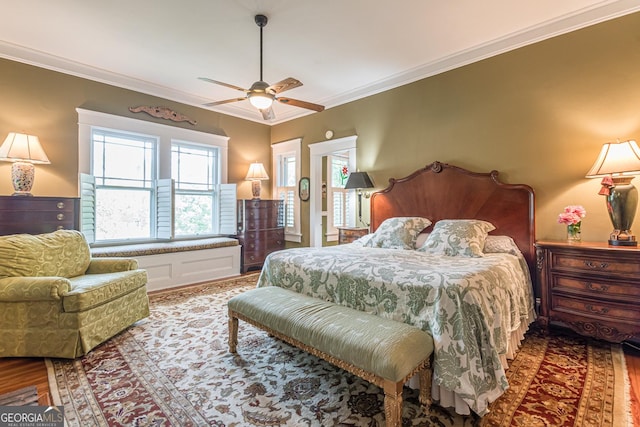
[77,109,236,243]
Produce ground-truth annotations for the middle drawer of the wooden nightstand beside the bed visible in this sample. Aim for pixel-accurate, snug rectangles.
[551,274,640,307]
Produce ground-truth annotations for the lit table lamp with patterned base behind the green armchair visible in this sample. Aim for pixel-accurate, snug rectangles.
[0,132,51,196]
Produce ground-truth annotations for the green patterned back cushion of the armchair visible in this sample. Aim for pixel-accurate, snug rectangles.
[0,230,91,278]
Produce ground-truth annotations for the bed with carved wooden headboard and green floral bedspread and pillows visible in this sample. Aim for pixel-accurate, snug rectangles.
[257,162,535,416]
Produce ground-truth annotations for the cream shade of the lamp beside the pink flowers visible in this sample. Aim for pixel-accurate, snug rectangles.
[586,140,640,178]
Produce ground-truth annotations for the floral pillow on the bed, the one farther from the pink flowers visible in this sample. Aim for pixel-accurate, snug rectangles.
[363,217,431,250]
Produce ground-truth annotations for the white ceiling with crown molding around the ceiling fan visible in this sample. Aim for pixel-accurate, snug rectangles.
[0,0,640,124]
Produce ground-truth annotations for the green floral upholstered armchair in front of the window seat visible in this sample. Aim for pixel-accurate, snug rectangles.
[0,230,149,359]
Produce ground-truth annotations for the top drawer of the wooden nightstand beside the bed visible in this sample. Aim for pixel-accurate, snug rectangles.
[552,252,640,277]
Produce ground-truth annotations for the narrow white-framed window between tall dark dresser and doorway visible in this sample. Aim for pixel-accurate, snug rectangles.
[271,138,302,243]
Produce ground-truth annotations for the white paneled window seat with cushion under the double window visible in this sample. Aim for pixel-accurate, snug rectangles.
[91,237,240,291]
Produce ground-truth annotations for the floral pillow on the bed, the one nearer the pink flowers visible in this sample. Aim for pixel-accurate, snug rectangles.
[418,219,495,257]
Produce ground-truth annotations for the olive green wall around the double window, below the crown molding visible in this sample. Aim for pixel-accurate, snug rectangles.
[0,59,271,202]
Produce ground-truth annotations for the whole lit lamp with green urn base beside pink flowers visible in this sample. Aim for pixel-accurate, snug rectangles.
[587,141,640,246]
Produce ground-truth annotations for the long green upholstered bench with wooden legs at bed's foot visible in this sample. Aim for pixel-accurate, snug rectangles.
[228,286,433,426]
